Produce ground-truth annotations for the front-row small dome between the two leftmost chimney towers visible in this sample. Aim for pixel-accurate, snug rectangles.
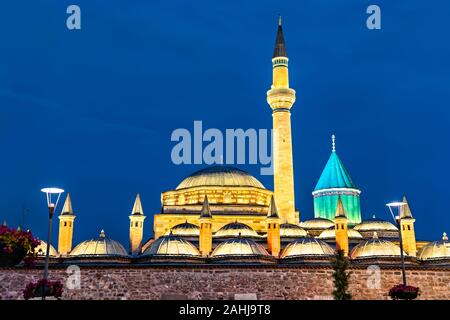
[70,230,128,256]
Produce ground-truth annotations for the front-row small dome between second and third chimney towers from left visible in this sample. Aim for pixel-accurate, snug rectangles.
[143,234,200,256]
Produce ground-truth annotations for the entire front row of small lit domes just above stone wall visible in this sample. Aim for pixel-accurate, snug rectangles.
[38,231,450,260]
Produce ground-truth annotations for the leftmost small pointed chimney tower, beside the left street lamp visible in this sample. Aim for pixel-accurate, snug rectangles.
[58,193,75,255]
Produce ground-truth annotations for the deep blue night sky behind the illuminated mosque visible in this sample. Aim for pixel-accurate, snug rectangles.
[0,0,450,246]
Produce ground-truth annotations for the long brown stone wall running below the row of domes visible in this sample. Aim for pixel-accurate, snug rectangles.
[0,266,450,300]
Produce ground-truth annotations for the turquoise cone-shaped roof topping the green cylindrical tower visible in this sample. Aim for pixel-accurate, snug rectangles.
[314,151,356,191]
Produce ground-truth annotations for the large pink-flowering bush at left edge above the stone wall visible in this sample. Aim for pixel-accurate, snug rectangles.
[0,225,41,266]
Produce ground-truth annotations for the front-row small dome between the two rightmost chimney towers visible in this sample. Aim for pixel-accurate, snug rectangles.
[350,232,406,259]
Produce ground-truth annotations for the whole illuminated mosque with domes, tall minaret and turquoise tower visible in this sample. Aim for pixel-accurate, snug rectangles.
[33,18,450,266]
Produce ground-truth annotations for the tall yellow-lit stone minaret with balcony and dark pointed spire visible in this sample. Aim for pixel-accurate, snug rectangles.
[267,16,299,223]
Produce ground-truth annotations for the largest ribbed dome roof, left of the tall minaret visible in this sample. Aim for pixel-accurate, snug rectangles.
[176,166,264,190]
